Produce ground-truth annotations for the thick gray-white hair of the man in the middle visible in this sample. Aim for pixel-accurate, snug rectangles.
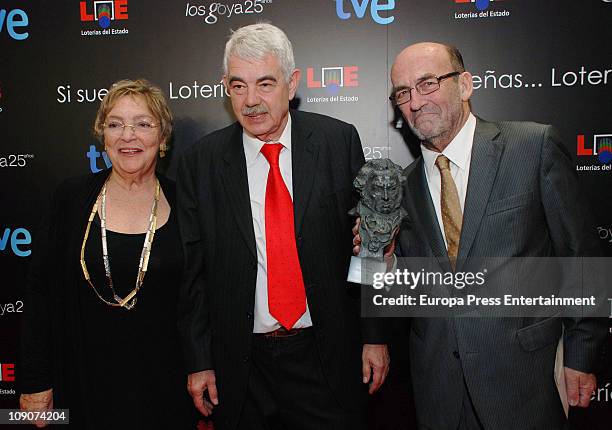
[223,23,295,82]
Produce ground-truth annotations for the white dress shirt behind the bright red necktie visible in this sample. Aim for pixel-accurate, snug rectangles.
[242,117,312,333]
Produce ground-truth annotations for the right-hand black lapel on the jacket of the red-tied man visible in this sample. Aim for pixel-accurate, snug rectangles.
[291,111,320,236]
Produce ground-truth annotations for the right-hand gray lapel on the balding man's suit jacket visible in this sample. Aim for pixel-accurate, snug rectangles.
[457,119,503,271]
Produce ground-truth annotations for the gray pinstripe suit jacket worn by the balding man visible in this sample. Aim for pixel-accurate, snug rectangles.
[398,120,605,430]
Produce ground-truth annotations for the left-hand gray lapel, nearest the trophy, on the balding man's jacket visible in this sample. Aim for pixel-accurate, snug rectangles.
[403,157,451,271]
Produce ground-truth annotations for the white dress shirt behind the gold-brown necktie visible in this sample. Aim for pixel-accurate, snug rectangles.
[417,113,476,248]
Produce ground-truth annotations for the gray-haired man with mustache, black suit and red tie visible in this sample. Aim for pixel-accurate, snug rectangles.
[177,24,389,430]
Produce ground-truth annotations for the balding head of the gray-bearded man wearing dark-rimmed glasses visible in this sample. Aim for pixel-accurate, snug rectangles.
[391,42,472,152]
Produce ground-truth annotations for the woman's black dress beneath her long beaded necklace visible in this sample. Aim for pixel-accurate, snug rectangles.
[77,207,195,429]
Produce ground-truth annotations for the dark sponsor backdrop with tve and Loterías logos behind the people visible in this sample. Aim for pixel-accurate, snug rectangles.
[0,0,612,429]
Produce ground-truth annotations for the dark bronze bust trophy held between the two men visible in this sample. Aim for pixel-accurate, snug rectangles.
[349,159,407,260]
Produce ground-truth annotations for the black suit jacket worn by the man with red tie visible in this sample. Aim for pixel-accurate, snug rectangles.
[177,110,380,428]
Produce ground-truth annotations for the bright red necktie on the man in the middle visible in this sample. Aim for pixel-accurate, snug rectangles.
[261,143,306,329]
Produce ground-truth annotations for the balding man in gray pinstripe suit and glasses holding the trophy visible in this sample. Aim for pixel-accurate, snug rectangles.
[354,43,605,430]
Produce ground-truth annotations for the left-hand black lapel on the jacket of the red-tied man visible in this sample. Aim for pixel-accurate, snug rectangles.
[221,123,257,258]
